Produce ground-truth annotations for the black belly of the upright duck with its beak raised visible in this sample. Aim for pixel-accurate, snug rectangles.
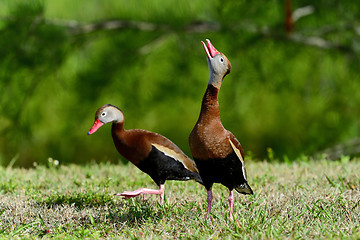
[194,152,247,193]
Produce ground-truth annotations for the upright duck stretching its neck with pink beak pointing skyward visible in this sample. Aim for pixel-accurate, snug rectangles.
[189,39,253,221]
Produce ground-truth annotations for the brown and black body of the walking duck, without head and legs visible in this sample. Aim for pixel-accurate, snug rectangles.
[113,125,202,185]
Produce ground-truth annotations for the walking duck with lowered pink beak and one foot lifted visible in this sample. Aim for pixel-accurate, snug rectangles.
[88,104,202,204]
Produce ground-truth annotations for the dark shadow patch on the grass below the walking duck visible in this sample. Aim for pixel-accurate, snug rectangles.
[37,192,165,226]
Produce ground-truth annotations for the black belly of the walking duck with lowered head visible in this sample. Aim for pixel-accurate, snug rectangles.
[137,146,202,186]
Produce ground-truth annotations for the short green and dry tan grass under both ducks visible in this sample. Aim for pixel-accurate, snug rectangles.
[0,159,360,239]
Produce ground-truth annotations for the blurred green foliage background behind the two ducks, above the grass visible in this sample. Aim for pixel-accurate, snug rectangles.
[0,0,360,167]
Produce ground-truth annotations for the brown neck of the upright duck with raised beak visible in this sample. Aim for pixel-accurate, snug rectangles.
[200,84,220,118]
